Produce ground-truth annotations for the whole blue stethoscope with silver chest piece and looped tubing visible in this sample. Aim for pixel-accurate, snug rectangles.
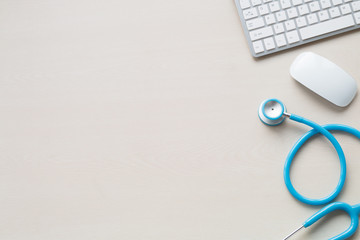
[259,99,360,240]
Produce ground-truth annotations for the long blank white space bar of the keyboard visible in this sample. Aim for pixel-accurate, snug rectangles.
[299,15,355,40]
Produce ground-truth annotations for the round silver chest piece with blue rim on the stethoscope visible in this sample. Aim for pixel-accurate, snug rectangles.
[259,98,290,126]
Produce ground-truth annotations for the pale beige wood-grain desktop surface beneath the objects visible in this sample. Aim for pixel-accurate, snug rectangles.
[0,0,360,240]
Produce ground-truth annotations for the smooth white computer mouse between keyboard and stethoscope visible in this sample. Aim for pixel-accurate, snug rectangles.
[290,52,357,107]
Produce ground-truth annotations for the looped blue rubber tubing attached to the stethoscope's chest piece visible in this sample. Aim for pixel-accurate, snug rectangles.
[284,114,360,205]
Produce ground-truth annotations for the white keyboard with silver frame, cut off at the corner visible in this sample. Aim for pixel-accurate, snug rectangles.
[235,0,360,57]
